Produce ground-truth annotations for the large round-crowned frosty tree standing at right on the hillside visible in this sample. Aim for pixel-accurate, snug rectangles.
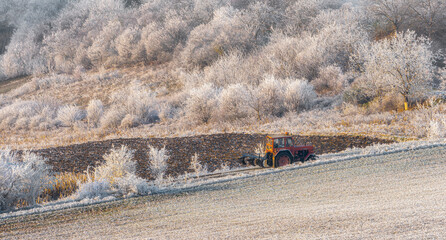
[360,31,435,109]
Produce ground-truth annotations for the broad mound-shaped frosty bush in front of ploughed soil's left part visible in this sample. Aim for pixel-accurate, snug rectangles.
[75,145,150,199]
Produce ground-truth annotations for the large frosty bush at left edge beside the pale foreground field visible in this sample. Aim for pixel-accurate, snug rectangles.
[0,150,50,210]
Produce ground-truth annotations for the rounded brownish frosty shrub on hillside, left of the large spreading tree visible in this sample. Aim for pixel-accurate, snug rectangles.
[311,65,347,96]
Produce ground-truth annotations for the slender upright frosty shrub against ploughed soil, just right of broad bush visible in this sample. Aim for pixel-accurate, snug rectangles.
[149,145,169,181]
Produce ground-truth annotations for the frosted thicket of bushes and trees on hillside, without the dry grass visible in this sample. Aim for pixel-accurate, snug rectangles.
[0,0,446,130]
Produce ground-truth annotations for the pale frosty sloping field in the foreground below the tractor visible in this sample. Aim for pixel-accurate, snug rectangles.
[0,146,446,239]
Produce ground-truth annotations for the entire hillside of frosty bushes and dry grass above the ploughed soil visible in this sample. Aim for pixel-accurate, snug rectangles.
[0,0,446,148]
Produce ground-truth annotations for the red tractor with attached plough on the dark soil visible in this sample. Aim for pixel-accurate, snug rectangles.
[240,135,316,168]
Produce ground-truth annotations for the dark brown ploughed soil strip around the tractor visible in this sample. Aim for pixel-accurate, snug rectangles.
[33,133,393,178]
